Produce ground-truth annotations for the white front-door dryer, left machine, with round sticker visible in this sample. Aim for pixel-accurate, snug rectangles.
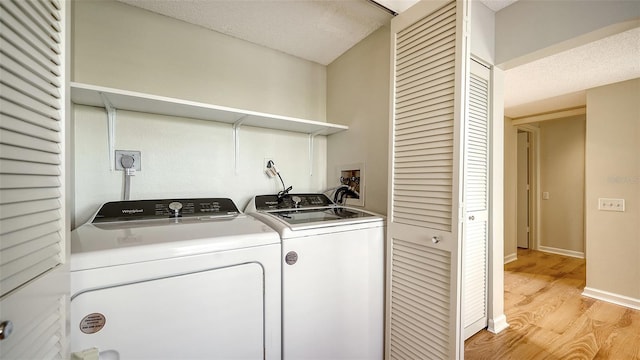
[70,198,281,360]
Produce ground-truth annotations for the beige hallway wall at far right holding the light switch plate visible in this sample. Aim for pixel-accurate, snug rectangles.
[585,79,640,308]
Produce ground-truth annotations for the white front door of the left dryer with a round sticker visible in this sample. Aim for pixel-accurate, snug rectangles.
[71,262,264,360]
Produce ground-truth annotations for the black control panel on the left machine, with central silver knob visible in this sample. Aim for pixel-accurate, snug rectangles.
[92,198,240,223]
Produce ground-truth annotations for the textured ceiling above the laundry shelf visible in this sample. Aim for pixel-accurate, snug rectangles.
[119,0,392,65]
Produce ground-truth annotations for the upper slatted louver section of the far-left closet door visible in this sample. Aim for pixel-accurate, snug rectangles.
[0,1,62,296]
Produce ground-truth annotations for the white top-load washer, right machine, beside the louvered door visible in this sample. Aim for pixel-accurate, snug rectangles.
[245,194,384,360]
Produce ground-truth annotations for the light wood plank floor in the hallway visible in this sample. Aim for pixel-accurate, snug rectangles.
[464,249,640,360]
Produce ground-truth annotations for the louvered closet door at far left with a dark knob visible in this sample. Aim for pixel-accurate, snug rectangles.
[0,0,68,359]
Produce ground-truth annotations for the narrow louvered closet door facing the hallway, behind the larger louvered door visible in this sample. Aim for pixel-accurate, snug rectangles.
[462,61,491,339]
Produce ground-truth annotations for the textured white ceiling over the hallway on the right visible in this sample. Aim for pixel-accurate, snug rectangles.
[504,28,640,117]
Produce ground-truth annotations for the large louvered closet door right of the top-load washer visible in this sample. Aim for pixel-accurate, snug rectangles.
[386,1,468,359]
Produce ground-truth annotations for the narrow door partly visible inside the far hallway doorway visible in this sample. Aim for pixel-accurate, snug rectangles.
[516,131,530,249]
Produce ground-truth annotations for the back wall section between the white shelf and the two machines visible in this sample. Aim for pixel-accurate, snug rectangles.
[74,106,326,226]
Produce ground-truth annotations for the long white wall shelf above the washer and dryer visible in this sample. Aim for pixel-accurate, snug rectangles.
[71,82,349,135]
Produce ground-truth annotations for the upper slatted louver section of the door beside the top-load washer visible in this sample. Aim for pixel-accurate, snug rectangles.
[393,3,456,231]
